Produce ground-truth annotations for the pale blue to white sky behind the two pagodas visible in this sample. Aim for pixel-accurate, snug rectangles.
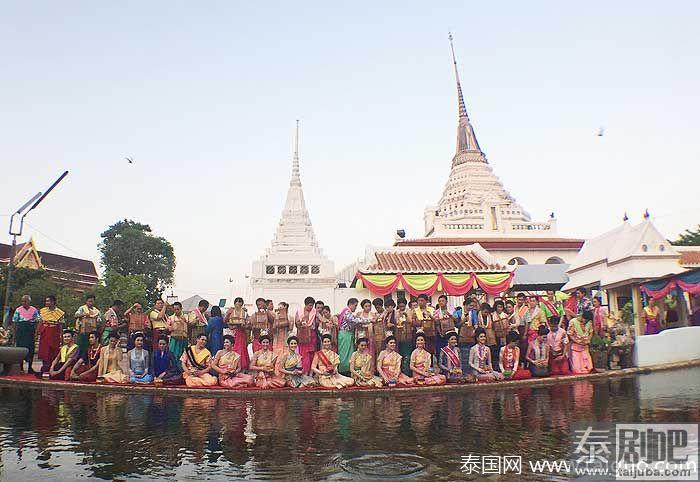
[0,1,700,299]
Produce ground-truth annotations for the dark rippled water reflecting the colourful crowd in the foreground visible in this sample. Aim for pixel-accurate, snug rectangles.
[0,368,700,482]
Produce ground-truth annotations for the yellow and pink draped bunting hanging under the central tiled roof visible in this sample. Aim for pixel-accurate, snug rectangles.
[355,272,515,296]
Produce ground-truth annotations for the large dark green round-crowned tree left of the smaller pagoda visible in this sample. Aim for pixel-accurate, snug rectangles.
[98,219,175,302]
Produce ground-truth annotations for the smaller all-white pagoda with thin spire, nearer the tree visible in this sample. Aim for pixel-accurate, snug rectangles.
[250,121,337,312]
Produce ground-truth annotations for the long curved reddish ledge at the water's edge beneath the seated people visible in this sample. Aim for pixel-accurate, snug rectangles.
[0,359,700,398]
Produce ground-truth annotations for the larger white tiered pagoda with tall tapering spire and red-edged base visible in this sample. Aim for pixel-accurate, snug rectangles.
[396,34,583,264]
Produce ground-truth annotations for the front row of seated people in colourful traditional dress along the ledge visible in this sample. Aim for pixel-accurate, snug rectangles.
[44,326,549,389]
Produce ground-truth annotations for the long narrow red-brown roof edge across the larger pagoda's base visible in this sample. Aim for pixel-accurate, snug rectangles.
[394,238,584,250]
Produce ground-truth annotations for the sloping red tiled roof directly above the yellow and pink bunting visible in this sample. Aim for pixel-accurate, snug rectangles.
[362,249,507,273]
